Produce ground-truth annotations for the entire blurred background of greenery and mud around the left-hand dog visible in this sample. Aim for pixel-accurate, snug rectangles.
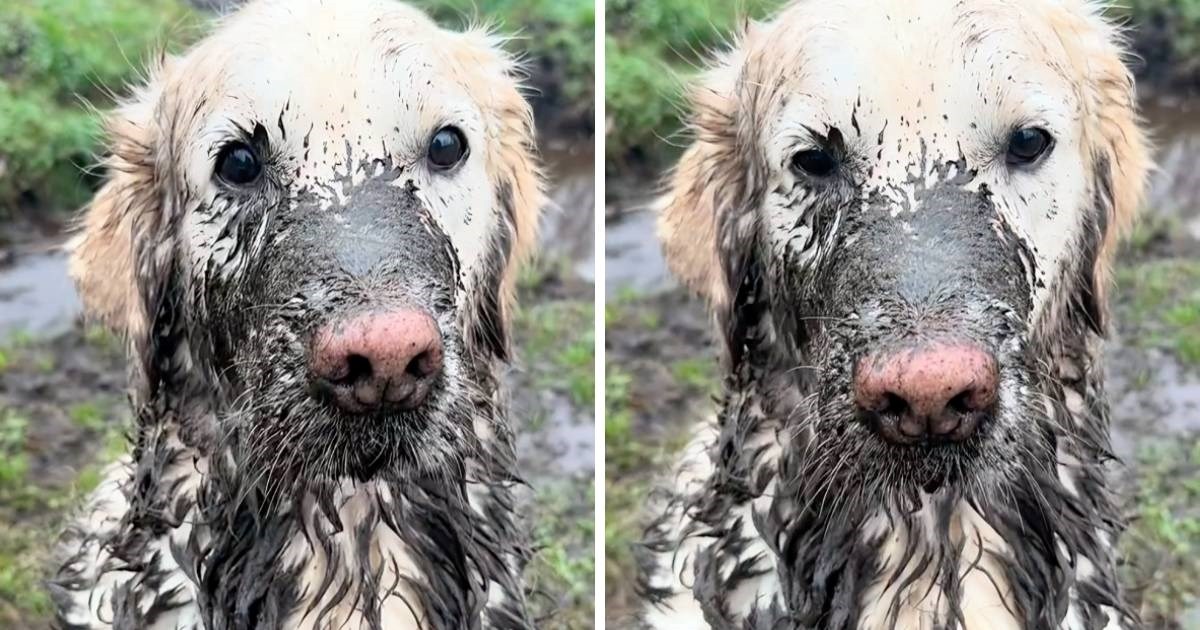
[0,0,595,630]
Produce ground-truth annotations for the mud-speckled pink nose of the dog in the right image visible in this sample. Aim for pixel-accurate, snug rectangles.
[854,343,1000,444]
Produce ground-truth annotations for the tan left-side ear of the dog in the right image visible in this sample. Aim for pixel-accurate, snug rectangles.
[658,49,746,311]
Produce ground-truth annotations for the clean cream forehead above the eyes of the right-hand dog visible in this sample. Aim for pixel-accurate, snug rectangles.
[763,0,1079,158]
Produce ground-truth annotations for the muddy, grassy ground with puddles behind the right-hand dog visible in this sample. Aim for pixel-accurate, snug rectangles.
[605,100,1200,629]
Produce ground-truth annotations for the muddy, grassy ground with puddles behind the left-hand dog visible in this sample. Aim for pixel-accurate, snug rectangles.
[0,132,595,630]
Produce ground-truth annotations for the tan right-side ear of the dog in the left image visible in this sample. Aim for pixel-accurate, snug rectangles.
[451,28,546,358]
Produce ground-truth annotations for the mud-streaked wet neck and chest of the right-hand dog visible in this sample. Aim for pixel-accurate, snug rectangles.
[662,301,1133,629]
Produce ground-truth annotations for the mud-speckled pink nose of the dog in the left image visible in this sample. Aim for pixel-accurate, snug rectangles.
[310,311,443,413]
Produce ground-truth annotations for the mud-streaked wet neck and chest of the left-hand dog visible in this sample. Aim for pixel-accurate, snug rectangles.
[104,338,532,630]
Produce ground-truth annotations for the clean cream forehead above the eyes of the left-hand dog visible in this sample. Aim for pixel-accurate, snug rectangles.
[184,0,466,112]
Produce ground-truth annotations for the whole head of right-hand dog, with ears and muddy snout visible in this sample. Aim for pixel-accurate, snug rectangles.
[660,0,1147,493]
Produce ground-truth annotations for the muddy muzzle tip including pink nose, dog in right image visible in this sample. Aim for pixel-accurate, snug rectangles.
[787,337,1036,494]
